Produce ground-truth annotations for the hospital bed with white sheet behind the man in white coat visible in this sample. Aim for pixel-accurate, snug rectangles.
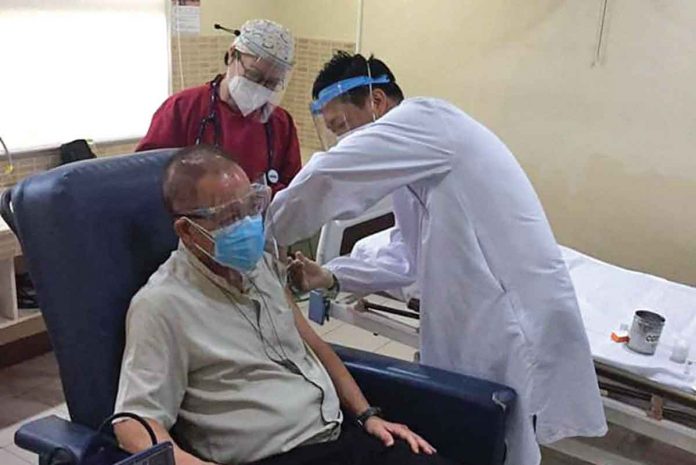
[310,199,696,465]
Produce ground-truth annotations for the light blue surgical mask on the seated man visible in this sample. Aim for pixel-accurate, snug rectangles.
[191,214,265,273]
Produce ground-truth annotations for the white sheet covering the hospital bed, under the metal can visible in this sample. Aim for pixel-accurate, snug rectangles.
[351,231,696,393]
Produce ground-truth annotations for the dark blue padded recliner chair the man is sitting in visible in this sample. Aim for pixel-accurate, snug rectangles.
[3,150,515,465]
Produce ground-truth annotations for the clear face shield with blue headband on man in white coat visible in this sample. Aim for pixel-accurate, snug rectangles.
[309,75,389,151]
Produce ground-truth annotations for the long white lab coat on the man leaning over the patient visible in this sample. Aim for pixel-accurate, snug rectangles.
[267,98,606,465]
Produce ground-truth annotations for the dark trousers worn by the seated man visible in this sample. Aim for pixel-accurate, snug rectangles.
[247,422,454,465]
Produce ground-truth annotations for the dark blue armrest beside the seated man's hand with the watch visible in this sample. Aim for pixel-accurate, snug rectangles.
[334,346,516,465]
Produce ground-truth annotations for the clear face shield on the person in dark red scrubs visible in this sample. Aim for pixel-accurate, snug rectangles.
[227,50,292,123]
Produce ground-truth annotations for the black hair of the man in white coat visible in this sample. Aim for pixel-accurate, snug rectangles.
[312,50,404,107]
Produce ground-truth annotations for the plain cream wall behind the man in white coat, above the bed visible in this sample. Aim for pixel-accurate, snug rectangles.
[362,0,696,285]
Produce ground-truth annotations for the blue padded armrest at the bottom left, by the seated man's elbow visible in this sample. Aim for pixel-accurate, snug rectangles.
[15,415,127,465]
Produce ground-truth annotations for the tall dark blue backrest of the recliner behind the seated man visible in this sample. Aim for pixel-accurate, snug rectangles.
[12,150,177,427]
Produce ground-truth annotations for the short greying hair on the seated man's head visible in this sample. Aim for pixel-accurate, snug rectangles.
[162,144,239,216]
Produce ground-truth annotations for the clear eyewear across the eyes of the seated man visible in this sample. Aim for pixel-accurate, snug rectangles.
[176,184,271,227]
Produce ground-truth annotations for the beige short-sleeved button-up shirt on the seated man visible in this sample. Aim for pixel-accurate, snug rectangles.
[115,244,342,464]
